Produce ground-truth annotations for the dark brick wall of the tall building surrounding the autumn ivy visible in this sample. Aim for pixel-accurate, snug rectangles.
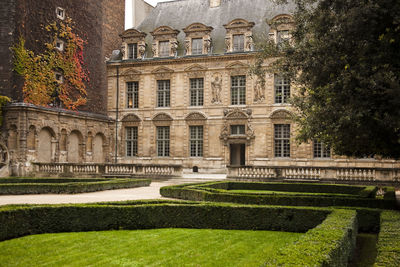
[0,0,125,113]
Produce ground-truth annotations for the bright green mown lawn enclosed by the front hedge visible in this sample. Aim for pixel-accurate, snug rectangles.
[0,229,301,266]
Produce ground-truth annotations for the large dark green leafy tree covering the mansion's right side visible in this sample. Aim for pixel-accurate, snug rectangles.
[263,0,400,158]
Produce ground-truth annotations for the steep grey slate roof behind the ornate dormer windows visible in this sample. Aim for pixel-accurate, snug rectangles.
[137,0,295,55]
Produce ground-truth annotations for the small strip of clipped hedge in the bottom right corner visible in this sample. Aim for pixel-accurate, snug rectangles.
[374,211,400,267]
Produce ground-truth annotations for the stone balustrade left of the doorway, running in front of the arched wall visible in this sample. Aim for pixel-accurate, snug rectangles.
[33,163,182,177]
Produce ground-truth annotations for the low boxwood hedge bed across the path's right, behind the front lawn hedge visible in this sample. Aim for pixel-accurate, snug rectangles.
[160,182,396,209]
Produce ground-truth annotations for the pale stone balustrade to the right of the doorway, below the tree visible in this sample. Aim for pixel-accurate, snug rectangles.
[228,166,400,183]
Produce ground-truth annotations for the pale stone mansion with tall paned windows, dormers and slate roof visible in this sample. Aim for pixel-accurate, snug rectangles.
[107,0,399,173]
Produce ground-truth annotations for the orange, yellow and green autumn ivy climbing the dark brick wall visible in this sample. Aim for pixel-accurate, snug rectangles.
[12,18,89,110]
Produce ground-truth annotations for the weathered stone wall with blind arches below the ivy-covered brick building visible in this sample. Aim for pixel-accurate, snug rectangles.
[2,103,114,176]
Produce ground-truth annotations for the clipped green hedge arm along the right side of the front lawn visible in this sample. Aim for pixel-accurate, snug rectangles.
[265,210,358,266]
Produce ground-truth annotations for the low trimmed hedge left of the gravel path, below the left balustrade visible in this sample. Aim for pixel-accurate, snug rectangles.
[0,178,151,195]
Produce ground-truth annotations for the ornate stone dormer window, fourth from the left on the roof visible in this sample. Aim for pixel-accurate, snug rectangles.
[224,19,254,53]
